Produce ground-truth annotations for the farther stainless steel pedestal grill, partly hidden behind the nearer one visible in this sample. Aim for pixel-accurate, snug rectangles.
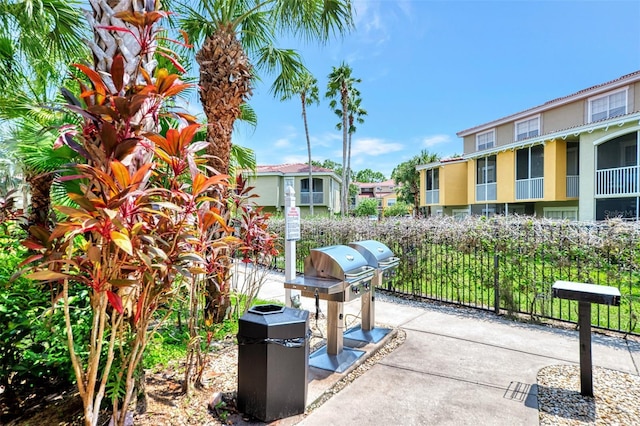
[344,240,400,343]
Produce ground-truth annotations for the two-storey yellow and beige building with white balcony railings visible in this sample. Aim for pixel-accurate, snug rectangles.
[417,71,640,221]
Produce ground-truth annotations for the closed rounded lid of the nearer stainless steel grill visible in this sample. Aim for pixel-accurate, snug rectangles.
[304,245,373,282]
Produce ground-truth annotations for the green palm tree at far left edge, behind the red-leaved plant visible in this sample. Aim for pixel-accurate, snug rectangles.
[0,0,87,230]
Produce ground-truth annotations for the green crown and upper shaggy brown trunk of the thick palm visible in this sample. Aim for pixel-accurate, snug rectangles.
[180,0,353,173]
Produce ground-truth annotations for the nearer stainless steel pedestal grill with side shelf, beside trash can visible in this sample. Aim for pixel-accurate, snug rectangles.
[284,245,376,372]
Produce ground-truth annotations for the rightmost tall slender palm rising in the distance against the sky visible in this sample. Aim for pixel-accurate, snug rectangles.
[325,62,361,216]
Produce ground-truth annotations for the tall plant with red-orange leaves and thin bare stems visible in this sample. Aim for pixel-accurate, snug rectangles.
[17,12,233,424]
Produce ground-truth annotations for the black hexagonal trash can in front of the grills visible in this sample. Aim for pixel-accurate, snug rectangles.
[238,305,309,422]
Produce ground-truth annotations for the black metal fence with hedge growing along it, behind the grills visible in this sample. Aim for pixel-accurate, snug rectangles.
[271,217,640,334]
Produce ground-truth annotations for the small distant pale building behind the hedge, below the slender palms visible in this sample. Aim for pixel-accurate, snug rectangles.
[247,164,342,216]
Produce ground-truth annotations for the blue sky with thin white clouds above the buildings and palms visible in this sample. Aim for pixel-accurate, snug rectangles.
[186,0,640,178]
